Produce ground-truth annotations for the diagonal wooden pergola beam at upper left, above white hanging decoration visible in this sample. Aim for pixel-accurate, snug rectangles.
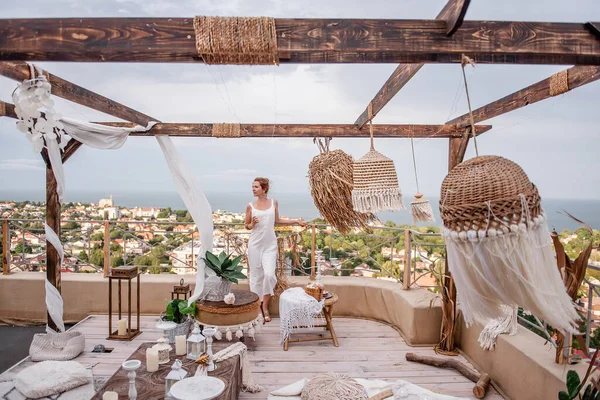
[0,62,153,126]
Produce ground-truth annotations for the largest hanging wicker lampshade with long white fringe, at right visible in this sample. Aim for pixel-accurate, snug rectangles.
[440,156,578,331]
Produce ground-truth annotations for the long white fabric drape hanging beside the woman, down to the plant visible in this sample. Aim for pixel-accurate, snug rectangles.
[156,136,214,304]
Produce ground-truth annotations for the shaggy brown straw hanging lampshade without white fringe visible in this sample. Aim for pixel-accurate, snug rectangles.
[308,142,375,234]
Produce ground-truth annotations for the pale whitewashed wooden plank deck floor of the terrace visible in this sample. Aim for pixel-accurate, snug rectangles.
[2,315,502,400]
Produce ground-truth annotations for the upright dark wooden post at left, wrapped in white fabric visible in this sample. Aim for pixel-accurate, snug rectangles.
[46,165,61,331]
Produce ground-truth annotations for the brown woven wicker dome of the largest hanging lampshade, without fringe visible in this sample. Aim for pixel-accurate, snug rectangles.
[440,156,542,232]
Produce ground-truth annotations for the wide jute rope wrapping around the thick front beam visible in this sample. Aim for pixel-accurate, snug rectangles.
[194,16,279,65]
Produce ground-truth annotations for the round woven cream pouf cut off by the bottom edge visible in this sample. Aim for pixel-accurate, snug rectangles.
[300,372,369,400]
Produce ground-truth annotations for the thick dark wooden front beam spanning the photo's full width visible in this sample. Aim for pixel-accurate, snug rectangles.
[0,18,600,65]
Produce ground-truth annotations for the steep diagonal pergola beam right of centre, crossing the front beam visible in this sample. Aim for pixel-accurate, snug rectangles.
[354,0,469,128]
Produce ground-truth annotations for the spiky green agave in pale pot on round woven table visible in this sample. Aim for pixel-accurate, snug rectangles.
[203,251,247,301]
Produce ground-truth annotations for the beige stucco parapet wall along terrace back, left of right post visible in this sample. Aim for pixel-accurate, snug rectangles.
[0,272,442,345]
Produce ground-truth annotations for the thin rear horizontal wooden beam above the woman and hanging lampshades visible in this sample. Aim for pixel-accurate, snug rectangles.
[97,122,491,138]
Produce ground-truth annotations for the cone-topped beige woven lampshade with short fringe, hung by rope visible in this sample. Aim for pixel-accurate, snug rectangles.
[352,103,406,213]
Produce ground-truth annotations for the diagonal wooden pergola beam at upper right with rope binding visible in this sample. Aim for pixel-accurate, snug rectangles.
[446,66,600,128]
